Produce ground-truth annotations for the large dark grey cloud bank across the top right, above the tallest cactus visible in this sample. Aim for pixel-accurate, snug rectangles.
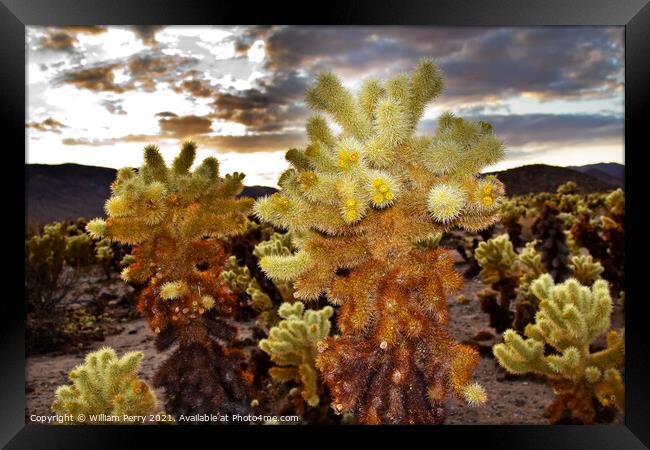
[256,27,623,98]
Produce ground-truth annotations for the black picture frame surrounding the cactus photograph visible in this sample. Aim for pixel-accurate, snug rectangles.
[6,0,650,449]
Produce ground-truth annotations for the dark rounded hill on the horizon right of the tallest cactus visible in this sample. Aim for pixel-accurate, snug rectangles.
[484,164,617,196]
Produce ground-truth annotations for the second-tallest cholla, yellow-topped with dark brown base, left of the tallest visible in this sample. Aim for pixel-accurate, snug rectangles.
[87,142,252,414]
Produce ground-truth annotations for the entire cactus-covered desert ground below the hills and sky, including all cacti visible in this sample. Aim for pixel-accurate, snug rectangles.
[25,36,624,426]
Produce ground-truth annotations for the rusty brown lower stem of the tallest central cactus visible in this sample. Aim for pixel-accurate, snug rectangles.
[317,249,478,424]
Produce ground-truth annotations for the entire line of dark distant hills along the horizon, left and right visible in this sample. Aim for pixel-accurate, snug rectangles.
[25,164,623,225]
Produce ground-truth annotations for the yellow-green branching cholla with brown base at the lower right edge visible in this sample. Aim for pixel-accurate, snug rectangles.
[493,274,624,423]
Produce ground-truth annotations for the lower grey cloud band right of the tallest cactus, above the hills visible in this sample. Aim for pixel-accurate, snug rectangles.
[418,114,623,147]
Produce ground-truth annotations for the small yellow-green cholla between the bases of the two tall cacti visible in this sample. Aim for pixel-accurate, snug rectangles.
[259,302,334,406]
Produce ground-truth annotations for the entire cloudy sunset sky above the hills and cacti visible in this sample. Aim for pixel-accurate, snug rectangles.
[25,26,624,186]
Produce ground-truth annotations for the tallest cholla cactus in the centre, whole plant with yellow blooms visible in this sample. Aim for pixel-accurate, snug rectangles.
[254,59,503,423]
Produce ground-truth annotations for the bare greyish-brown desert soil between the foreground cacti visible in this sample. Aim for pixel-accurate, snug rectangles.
[25,255,624,425]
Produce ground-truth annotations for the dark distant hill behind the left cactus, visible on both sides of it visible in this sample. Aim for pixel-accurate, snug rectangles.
[25,164,277,225]
